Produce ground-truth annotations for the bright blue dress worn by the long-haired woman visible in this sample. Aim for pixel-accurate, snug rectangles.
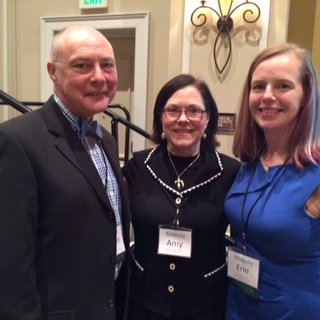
[225,162,320,320]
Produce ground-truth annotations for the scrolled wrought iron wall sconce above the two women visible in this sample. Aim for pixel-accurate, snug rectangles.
[191,0,260,74]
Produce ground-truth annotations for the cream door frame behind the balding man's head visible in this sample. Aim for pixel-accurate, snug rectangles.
[40,12,149,151]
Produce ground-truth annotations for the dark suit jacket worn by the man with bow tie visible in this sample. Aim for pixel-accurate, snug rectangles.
[0,97,129,320]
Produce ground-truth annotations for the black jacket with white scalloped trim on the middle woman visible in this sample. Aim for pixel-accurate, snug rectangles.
[124,146,240,319]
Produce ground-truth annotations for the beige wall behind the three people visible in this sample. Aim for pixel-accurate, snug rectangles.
[0,0,320,158]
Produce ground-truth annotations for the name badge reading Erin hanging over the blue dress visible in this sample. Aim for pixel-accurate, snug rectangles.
[228,247,260,295]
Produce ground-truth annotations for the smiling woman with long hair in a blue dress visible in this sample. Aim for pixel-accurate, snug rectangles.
[225,44,320,320]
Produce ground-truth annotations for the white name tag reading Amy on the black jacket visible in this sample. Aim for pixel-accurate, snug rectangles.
[158,225,192,258]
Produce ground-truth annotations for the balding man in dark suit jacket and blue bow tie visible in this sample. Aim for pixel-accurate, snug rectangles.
[0,26,129,320]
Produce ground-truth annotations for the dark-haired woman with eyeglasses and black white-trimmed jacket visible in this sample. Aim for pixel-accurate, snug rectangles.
[124,74,239,320]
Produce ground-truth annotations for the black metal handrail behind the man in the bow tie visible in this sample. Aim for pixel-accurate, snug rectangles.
[0,90,150,163]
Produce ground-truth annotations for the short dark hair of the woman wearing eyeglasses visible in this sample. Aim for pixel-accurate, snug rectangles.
[151,74,220,148]
